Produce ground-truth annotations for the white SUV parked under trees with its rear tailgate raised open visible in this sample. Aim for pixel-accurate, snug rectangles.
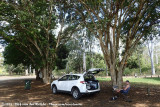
[51,68,104,99]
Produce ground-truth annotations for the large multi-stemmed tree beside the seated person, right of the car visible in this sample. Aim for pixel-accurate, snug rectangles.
[69,0,160,88]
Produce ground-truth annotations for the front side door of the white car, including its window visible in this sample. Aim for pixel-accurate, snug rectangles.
[57,75,69,91]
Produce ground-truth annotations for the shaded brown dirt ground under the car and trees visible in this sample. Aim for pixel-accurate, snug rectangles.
[0,77,160,107]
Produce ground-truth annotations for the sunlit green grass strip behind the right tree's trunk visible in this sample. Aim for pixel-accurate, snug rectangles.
[97,77,160,85]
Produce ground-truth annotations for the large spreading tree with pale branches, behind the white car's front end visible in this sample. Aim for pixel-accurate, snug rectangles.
[0,0,70,83]
